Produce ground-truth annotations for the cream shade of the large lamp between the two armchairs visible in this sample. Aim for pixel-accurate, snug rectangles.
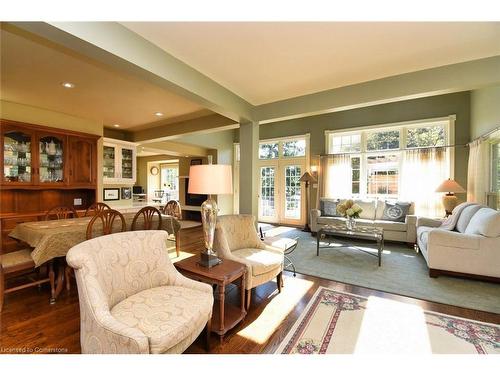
[188,164,233,195]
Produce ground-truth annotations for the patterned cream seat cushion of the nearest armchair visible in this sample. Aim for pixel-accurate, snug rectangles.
[111,286,213,353]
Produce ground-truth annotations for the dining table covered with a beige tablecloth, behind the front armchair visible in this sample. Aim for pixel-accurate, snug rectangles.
[9,212,181,302]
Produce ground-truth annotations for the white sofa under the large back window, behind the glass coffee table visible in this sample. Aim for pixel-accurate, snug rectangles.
[310,198,417,244]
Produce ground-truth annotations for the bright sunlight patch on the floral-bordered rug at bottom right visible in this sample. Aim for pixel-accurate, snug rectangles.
[354,296,432,354]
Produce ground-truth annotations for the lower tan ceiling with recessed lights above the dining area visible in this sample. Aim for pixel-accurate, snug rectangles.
[0,29,212,130]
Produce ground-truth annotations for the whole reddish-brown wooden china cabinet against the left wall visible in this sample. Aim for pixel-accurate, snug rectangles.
[0,120,99,253]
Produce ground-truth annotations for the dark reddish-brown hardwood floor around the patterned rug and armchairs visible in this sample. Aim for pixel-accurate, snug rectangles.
[0,227,500,354]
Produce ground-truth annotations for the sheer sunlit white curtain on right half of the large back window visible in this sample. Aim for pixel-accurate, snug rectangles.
[400,148,450,217]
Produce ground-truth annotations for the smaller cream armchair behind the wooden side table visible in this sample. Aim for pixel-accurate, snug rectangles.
[213,215,284,309]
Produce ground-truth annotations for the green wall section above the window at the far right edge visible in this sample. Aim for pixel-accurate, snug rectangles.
[470,86,500,139]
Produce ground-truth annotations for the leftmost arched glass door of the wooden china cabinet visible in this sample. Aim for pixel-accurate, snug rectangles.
[3,131,33,183]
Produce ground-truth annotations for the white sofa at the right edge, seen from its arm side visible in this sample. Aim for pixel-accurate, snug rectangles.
[417,204,500,281]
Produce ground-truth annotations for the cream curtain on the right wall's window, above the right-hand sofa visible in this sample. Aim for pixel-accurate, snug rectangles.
[467,139,490,204]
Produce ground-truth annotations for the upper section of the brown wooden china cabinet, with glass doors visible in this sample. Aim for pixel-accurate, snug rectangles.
[0,120,98,189]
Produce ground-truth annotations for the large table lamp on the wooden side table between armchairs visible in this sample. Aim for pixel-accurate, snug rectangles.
[188,164,233,267]
